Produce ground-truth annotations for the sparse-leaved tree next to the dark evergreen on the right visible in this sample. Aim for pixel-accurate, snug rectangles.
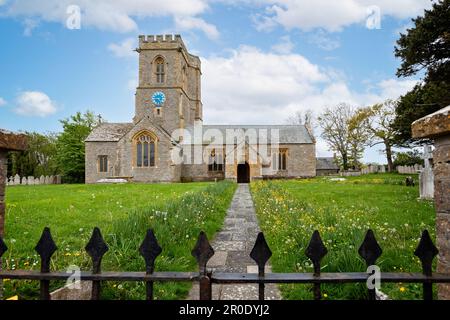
[351,100,397,172]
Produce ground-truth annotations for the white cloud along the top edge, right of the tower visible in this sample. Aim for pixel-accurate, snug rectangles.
[251,0,431,32]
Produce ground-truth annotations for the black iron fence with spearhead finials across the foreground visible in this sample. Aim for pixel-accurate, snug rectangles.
[0,228,450,300]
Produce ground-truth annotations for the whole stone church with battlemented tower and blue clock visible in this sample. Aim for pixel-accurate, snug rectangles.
[85,35,316,183]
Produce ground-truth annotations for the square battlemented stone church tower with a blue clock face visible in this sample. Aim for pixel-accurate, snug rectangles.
[133,35,203,134]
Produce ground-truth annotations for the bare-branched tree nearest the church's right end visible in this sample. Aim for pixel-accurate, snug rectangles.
[317,103,365,170]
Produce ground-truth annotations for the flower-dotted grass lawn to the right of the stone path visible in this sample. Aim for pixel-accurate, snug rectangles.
[251,174,435,299]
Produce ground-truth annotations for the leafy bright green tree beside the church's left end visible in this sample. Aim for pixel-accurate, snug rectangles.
[57,111,103,183]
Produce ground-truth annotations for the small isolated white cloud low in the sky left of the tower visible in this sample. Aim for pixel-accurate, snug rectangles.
[15,91,56,118]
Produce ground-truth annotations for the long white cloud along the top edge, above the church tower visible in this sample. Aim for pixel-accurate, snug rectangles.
[0,0,214,35]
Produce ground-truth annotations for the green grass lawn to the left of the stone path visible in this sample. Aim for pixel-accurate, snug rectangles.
[3,182,235,299]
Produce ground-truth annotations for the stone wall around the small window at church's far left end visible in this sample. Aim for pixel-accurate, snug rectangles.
[85,142,117,183]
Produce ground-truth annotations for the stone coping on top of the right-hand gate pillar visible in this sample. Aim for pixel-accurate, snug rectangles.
[412,106,450,139]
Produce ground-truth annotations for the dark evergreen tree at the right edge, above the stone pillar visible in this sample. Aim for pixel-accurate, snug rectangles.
[393,0,450,146]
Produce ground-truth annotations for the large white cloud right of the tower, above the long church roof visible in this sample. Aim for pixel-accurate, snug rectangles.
[202,46,416,124]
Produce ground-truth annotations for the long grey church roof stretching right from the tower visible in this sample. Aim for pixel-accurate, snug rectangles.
[203,125,315,144]
